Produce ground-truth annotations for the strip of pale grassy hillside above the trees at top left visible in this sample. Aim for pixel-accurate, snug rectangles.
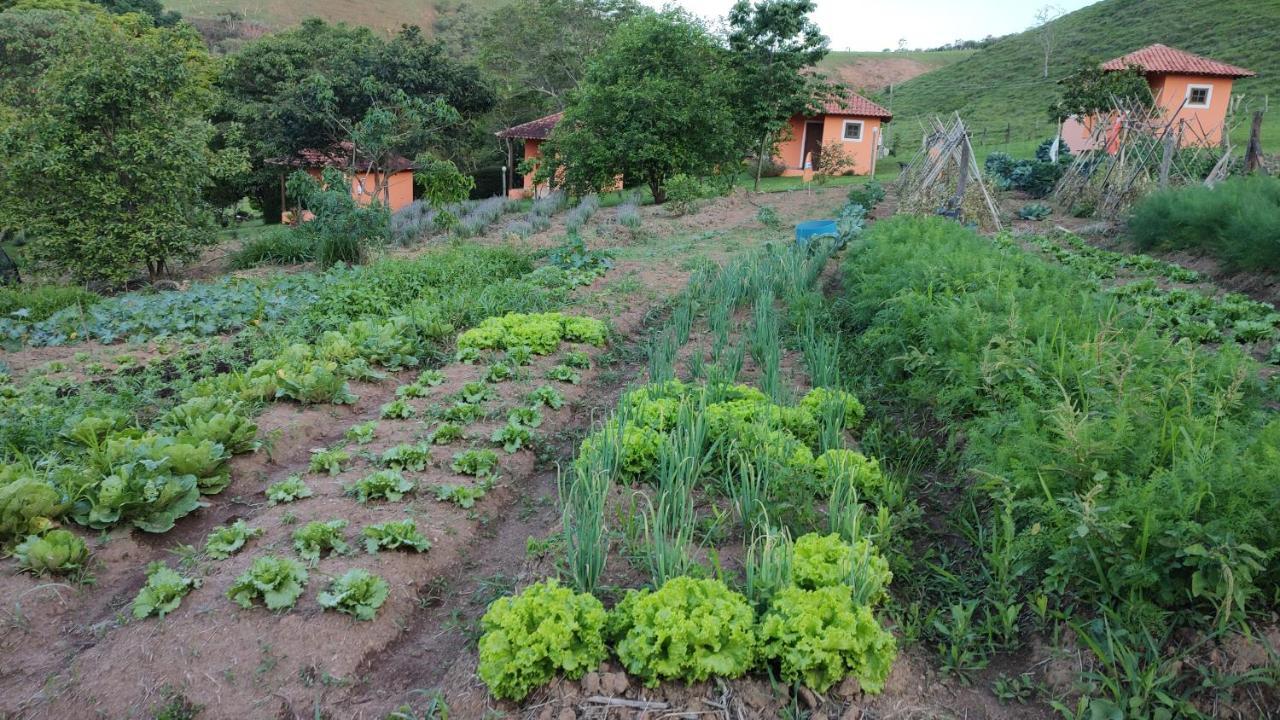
[165,0,503,32]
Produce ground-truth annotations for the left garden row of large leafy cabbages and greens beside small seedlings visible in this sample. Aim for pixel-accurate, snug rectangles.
[0,249,586,544]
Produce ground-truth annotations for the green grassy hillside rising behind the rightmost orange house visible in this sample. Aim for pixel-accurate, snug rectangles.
[879,0,1280,152]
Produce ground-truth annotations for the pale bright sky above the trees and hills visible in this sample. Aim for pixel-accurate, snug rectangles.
[643,0,1097,50]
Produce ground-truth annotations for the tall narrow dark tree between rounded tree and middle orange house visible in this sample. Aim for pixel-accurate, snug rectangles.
[728,0,829,191]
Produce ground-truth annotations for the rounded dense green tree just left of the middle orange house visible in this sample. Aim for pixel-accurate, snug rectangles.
[536,10,741,202]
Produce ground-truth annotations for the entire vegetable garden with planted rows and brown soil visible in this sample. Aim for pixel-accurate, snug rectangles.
[0,180,1280,717]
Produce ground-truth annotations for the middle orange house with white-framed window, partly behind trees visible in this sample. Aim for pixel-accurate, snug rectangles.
[773,92,893,177]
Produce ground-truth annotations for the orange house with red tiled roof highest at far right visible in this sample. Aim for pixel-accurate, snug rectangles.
[1062,44,1257,150]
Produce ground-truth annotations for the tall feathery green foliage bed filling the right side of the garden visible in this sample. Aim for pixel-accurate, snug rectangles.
[838,218,1280,629]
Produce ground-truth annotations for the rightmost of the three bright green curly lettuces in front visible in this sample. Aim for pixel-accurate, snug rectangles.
[759,585,897,693]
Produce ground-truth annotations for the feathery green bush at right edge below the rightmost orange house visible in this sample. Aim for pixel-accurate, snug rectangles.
[1129,176,1280,272]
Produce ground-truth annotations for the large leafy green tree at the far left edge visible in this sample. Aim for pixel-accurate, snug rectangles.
[0,14,243,284]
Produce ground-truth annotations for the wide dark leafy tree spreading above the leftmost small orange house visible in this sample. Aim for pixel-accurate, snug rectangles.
[218,19,494,217]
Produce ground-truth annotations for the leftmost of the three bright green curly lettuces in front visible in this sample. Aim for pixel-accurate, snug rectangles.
[476,579,607,701]
